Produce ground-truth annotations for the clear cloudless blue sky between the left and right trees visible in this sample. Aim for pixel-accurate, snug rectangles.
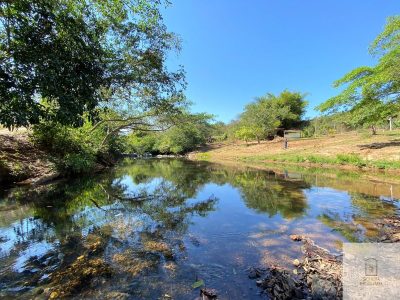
[164,0,400,122]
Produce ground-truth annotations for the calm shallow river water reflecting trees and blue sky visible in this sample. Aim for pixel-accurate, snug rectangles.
[0,159,400,299]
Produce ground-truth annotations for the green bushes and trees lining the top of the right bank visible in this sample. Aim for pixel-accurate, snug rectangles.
[209,16,400,142]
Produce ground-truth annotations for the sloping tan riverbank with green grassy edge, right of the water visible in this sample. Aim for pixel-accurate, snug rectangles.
[189,130,400,175]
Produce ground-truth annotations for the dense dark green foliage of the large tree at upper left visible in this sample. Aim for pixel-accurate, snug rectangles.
[0,0,185,127]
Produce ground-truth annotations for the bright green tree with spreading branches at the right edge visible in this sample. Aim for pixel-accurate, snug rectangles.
[317,16,400,134]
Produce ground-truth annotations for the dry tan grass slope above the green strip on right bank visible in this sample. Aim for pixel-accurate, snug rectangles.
[191,130,400,168]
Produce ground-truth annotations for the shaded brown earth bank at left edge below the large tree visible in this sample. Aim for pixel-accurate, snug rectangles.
[0,129,58,184]
